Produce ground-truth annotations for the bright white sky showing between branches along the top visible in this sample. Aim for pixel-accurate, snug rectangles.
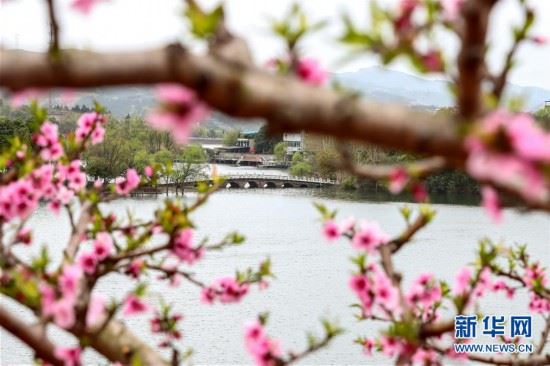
[0,0,550,89]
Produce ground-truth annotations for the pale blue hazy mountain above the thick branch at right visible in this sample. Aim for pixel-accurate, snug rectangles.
[333,67,550,112]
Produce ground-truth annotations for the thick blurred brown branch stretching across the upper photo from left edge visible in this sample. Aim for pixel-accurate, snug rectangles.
[0,46,466,160]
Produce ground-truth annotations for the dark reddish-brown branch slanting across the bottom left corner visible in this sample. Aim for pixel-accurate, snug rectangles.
[0,307,63,366]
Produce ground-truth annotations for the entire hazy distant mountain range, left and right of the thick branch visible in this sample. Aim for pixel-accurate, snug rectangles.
[50,67,550,120]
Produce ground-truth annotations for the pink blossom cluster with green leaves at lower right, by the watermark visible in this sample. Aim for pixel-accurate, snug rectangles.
[317,205,550,365]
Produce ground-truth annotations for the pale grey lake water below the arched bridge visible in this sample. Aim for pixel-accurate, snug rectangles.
[0,189,550,365]
